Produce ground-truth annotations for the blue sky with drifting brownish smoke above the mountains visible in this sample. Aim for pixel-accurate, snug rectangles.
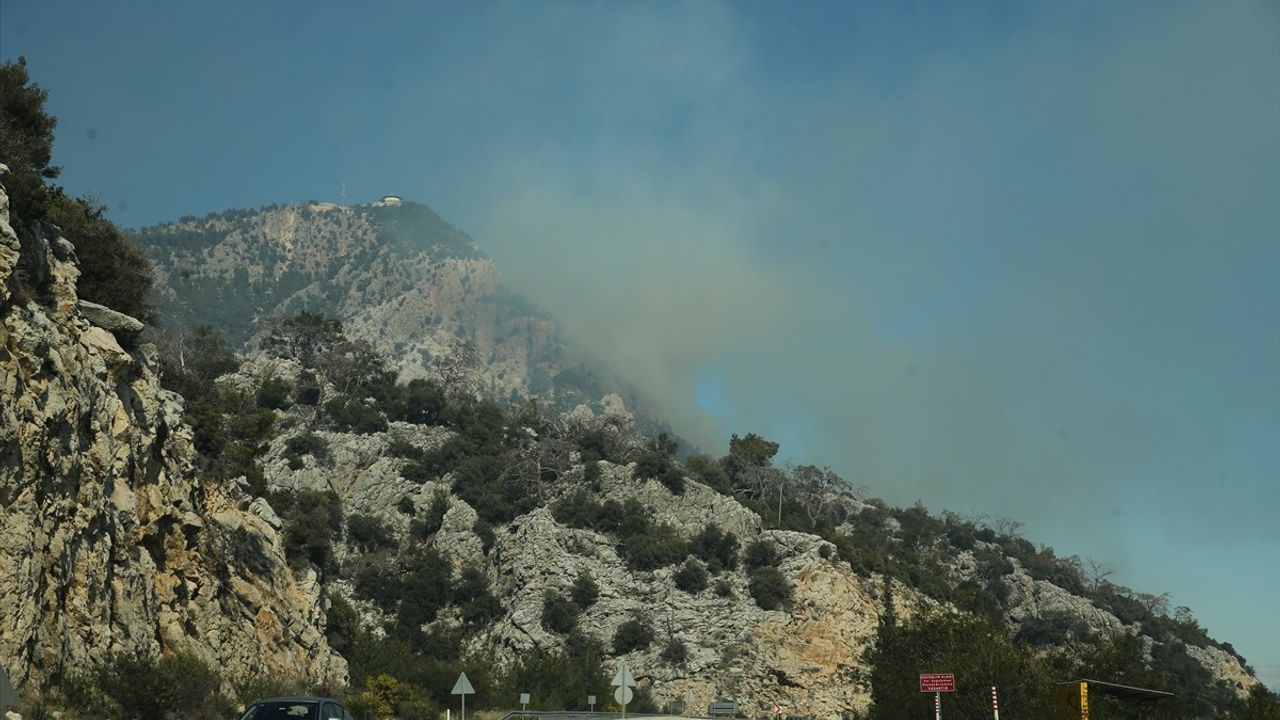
[0,0,1280,687]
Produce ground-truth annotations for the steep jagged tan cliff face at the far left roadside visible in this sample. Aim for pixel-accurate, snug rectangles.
[0,169,347,687]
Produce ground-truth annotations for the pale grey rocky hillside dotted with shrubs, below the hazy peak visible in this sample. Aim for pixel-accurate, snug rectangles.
[209,338,1257,717]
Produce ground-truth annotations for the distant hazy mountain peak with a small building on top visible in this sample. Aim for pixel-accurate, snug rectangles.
[131,202,657,427]
